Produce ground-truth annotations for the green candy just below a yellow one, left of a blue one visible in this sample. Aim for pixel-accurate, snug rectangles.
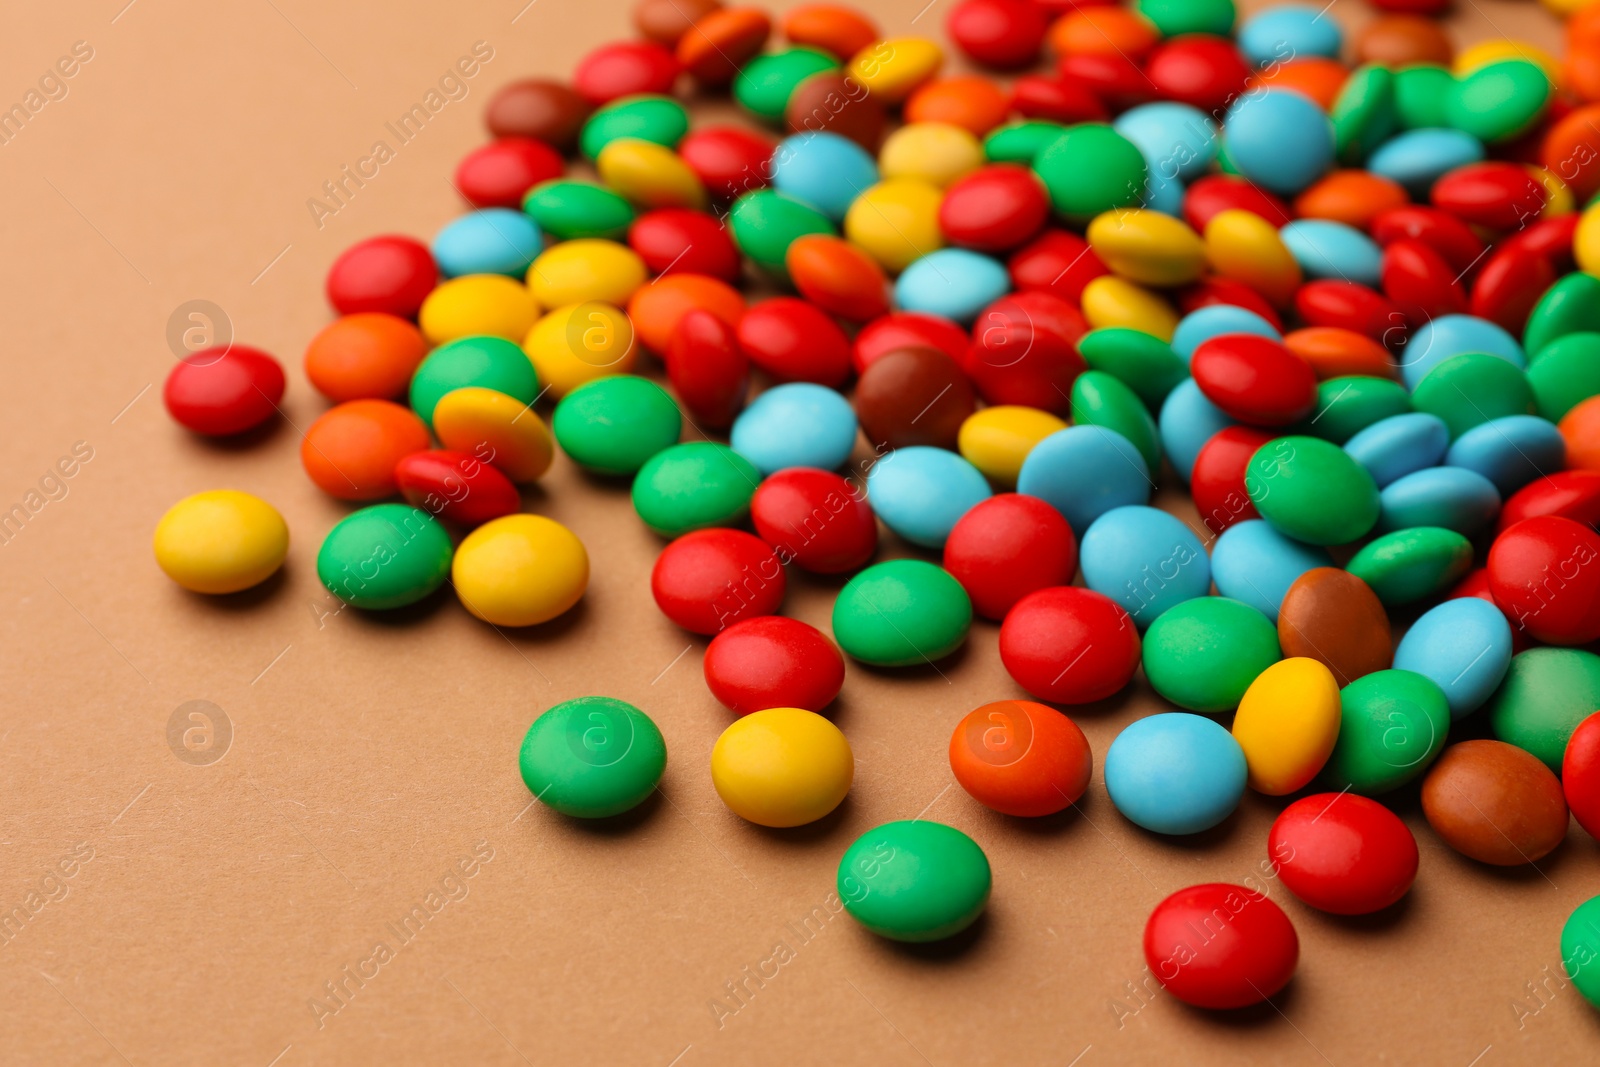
[550,374,683,474]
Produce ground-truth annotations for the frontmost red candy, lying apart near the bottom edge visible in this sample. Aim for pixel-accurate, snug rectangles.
[1144,883,1299,1008]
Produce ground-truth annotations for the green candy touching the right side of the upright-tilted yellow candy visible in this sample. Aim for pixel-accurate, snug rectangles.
[1322,670,1450,797]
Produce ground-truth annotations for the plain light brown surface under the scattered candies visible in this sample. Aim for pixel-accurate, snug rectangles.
[0,0,1600,1067]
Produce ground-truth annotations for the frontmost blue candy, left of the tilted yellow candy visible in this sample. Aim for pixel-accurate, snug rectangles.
[1106,712,1248,833]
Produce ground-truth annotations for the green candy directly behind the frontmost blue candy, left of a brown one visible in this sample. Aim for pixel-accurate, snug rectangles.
[1142,597,1283,712]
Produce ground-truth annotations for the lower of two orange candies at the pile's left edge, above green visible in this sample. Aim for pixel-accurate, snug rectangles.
[301,400,429,501]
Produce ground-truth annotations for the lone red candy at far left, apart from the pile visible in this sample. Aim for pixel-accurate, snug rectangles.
[162,344,283,437]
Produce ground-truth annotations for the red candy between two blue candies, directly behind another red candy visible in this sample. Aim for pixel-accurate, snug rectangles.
[944,493,1078,619]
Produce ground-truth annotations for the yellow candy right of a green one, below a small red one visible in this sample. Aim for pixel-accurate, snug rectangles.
[450,515,589,625]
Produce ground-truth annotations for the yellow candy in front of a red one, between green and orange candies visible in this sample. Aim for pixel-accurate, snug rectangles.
[710,707,856,827]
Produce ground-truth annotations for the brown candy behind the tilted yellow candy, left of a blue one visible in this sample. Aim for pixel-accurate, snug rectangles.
[1278,566,1394,689]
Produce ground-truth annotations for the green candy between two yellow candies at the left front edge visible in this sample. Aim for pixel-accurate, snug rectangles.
[317,504,454,611]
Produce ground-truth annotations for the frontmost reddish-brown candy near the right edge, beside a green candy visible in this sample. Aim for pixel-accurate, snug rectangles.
[1422,741,1566,867]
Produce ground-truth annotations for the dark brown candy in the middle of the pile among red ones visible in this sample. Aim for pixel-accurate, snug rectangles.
[856,346,976,451]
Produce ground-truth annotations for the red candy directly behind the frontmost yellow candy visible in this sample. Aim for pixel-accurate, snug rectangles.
[704,614,845,715]
